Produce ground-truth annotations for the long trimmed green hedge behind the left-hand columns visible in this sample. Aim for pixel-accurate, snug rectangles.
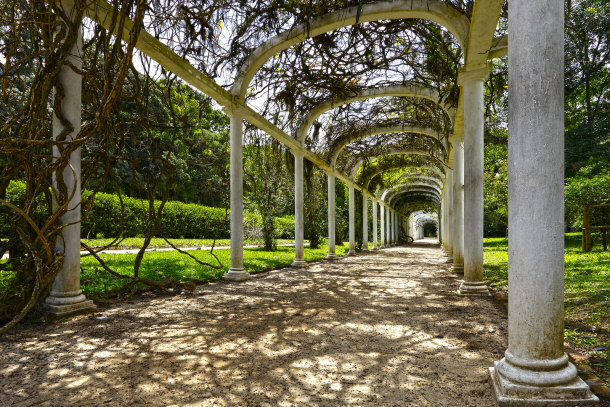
[0,181,294,239]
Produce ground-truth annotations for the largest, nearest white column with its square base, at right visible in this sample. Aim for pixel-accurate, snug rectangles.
[490,0,597,406]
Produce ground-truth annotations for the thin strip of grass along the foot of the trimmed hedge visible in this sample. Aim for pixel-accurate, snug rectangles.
[83,237,308,249]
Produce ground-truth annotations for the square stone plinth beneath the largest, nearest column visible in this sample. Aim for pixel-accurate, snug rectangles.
[489,361,599,407]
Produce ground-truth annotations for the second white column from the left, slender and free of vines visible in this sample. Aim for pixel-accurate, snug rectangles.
[222,109,251,281]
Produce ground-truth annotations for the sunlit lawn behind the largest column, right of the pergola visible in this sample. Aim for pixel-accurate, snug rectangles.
[484,232,610,383]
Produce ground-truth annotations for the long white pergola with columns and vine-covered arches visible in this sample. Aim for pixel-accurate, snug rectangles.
[46,0,597,406]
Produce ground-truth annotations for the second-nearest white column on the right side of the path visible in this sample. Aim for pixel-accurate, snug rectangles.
[458,68,489,295]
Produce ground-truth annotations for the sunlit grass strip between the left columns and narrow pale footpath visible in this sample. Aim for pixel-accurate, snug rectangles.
[81,241,348,298]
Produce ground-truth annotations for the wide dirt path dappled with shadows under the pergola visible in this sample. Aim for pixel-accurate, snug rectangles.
[0,244,507,407]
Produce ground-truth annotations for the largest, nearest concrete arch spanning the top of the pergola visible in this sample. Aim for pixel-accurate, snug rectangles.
[231,0,470,100]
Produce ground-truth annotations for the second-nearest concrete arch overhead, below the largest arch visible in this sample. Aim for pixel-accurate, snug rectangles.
[296,85,455,143]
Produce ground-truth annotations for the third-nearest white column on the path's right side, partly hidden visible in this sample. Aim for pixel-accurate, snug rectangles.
[451,142,464,273]
